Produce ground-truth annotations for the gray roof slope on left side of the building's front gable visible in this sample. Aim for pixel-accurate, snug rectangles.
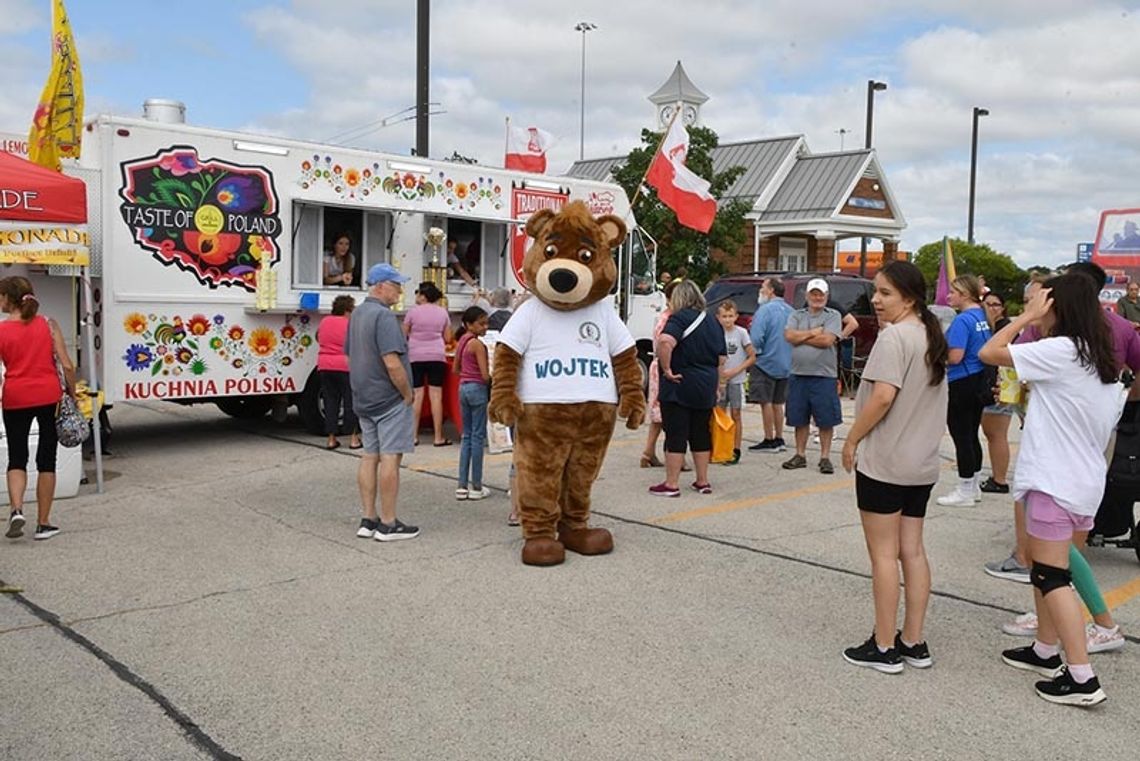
[760,150,871,222]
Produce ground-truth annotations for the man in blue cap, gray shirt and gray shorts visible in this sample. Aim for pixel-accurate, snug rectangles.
[344,264,420,541]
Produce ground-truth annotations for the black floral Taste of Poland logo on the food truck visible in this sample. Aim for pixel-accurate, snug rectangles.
[120,146,282,292]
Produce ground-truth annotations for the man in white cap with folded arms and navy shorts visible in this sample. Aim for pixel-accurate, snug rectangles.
[783,278,844,474]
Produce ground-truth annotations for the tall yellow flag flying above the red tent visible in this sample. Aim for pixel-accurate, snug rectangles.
[27,0,83,172]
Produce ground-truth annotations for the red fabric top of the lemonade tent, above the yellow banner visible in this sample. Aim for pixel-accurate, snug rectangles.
[0,152,87,224]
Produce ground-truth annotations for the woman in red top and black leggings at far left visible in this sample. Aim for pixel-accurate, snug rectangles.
[0,277,75,539]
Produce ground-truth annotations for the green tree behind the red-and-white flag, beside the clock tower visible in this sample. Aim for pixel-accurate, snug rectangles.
[613,126,750,284]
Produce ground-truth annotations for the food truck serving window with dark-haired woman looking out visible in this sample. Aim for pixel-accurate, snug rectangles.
[293,203,392,291]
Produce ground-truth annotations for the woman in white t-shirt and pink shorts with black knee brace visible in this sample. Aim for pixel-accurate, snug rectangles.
[980,272,1124,706]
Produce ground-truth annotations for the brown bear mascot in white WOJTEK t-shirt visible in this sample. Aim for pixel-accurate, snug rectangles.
[488,201,645,565]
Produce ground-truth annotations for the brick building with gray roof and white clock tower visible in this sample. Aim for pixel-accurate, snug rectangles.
[568,60,906,271]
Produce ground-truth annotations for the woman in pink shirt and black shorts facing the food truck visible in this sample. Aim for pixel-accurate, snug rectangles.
[404,283,451,447]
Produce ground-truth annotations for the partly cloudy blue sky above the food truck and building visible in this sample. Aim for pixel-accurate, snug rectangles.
[0,0,1140,267]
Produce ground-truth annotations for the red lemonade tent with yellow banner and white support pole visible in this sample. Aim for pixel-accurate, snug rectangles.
[0,152,103,492]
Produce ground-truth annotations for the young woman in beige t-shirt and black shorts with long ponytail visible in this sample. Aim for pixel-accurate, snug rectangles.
[842,261,950,673]
